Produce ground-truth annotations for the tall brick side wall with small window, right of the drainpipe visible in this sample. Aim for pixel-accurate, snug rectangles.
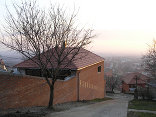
[79,62,106,100]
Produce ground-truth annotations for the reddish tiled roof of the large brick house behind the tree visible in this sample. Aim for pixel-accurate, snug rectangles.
[14,47,104,70]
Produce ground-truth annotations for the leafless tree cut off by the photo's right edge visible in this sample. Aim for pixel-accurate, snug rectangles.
[142,40,156,78]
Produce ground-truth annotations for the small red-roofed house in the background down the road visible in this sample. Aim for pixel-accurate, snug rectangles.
[122,72,150,93]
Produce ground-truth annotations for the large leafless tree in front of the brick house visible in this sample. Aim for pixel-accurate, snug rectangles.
[1,1,92,108]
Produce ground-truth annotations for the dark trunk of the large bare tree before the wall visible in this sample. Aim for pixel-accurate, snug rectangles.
[48,84,54,109]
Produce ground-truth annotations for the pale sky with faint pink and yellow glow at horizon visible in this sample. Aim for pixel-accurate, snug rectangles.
[0,0,156,56]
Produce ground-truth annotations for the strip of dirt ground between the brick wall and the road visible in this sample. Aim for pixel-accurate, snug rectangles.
[0,98,111,117]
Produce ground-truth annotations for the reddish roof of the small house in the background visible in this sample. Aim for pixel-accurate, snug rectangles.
[122,72,150,84]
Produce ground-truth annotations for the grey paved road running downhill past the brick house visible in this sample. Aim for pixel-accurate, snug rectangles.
[46,95,131,117]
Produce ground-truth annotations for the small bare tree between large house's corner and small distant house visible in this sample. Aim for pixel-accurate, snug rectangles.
[105,75,120,92]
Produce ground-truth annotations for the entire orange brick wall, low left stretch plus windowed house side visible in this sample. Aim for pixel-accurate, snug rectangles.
[0,62,106,109]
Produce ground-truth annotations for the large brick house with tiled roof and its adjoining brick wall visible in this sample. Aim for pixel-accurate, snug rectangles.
[0,49,106,109]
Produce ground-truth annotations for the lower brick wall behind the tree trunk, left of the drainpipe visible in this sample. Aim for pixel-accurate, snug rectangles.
[0,74,76,109]
